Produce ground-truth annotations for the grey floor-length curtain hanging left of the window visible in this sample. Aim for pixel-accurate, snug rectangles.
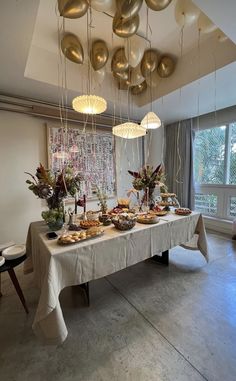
[165,119,194,209]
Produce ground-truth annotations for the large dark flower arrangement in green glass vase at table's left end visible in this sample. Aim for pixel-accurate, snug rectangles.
[25,164,82,230]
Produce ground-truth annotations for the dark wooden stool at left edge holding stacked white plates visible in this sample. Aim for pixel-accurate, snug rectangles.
[0,255,29,314]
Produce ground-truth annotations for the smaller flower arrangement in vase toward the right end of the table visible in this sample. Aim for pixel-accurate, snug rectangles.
[128,164,167,208]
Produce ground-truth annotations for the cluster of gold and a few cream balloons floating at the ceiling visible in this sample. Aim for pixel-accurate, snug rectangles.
[58,0,175,95]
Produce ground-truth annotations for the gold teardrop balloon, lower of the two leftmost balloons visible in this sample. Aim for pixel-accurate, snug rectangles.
[61,33,84,64]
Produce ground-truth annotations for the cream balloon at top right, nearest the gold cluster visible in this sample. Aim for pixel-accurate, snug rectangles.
[175,0,200,28]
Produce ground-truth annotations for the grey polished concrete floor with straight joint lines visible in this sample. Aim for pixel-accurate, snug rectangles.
[0,234,236,381]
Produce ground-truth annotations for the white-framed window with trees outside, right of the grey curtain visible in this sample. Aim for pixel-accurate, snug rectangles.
[194,122,236,219]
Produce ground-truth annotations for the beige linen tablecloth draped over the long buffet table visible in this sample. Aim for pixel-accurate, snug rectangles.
[24,212,208,345]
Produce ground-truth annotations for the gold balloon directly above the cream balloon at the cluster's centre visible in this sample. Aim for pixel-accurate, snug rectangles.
[112,13,139,38]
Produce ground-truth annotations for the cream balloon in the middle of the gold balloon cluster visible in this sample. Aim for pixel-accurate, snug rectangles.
[125,35,145,67]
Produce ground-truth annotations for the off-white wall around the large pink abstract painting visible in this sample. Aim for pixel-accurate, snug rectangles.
[0,111,142,243]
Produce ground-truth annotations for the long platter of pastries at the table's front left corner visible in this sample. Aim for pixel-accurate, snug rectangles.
[57,228,104,246]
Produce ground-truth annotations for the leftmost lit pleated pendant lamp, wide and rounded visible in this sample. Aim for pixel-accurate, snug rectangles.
[72,95,107,114]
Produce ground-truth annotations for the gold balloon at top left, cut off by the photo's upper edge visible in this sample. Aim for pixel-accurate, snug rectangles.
[58,0,89,19]
